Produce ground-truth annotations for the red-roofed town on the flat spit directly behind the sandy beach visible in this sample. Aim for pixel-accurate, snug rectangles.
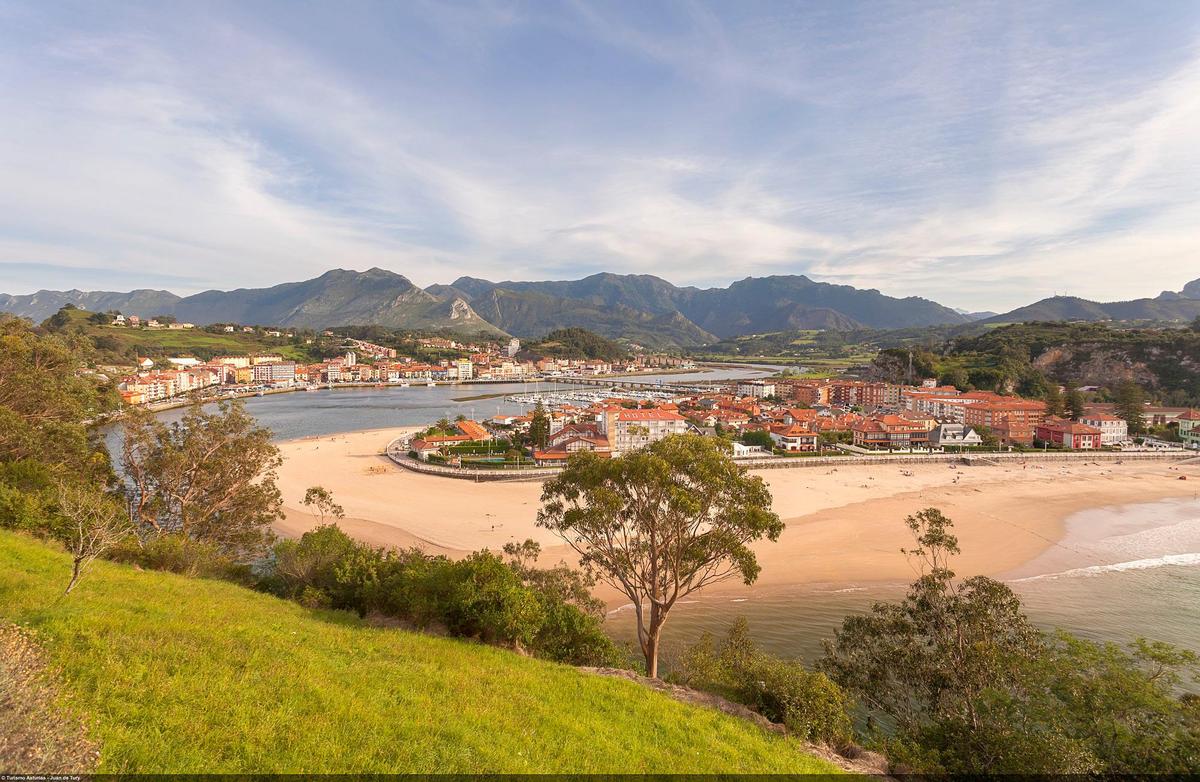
[406,378,1200,469]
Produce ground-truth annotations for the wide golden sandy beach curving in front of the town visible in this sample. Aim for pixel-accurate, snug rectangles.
[276,429,1200,602]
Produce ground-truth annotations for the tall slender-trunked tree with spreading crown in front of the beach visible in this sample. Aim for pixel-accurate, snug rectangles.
[538,434,784,678]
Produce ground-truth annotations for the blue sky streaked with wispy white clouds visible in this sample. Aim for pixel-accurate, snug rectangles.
[0,0,1200,311]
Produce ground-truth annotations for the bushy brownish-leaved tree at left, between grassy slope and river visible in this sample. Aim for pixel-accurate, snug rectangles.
[121,402,283,558]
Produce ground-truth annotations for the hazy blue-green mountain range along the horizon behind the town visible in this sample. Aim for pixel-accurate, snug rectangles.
[0,269,1200,348]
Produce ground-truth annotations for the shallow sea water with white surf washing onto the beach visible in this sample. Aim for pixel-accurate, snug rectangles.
[608,497,1200,681]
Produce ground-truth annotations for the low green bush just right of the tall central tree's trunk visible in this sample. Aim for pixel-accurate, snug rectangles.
[672,618,853,746]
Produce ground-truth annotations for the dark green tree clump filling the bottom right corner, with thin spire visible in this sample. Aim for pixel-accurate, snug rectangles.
[818,509,1200,774]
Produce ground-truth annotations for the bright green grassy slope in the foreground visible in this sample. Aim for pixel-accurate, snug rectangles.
[0,531,834,774]
